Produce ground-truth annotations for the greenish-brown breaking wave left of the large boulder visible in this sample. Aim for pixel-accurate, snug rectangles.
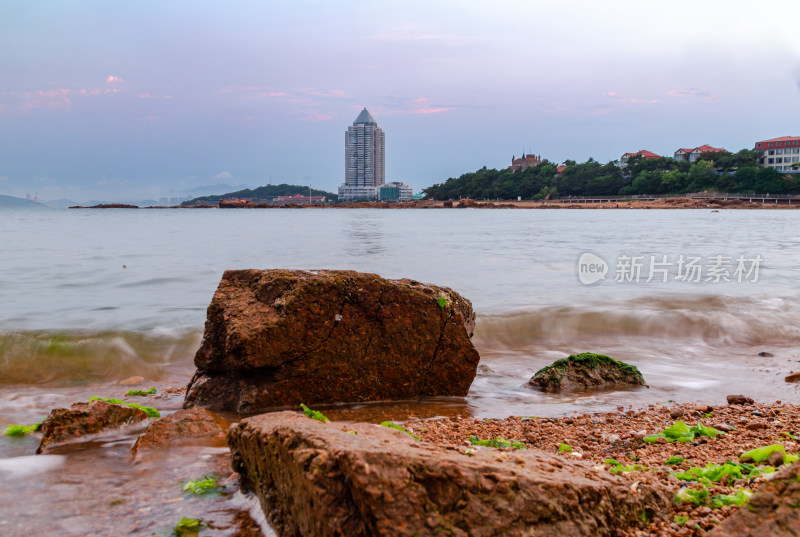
[0,330,202,385]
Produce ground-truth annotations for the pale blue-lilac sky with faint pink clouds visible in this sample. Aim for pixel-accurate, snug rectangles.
[0,0,800,201]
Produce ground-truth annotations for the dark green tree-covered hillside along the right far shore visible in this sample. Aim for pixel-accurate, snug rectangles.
[423,149,800,200]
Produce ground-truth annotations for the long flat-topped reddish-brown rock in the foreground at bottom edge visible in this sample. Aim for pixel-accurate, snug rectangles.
[228,412,670,537]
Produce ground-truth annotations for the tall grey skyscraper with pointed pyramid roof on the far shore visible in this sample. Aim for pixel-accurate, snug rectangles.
[339,108,386,201]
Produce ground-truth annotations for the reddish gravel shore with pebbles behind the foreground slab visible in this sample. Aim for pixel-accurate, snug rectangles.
[404,401,800,537]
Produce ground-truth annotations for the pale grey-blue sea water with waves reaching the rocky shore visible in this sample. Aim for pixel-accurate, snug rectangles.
[0,208,800,536]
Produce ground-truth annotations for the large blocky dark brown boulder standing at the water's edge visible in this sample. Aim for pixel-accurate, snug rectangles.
[184,270,479,413]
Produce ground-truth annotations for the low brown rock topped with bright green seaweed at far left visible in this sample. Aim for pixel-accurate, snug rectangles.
[36,401,147,453]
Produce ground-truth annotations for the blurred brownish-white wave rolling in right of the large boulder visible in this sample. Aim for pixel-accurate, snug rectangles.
[475,296,800,348]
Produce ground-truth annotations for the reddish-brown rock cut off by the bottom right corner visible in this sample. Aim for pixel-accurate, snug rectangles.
[708,463,800,537]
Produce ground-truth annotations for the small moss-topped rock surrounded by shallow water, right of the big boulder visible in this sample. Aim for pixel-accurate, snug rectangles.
[528,352,646,392]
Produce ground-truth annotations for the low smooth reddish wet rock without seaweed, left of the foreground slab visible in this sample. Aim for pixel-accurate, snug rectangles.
[131,408,228,456]
